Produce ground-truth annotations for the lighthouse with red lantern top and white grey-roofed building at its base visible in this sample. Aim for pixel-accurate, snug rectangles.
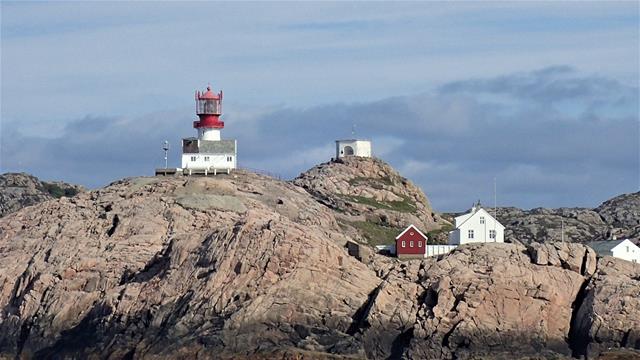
[182,86,237,175]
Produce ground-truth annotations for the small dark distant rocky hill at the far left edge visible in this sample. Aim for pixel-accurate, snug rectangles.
[0,173,85,217]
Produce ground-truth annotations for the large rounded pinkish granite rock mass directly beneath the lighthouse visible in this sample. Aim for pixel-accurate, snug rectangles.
[0,173,380,358]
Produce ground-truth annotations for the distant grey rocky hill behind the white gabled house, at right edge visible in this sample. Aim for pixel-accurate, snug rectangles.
[490,192,640,243]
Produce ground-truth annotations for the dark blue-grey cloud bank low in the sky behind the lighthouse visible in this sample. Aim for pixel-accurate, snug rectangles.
[1,66,640,211]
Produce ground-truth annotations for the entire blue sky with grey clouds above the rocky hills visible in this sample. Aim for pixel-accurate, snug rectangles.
[0,0,640,211]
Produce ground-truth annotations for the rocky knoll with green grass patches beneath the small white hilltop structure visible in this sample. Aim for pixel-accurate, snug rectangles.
[293,157,451,245]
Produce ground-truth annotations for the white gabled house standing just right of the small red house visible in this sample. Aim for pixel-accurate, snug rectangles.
[449,203,504,245]
